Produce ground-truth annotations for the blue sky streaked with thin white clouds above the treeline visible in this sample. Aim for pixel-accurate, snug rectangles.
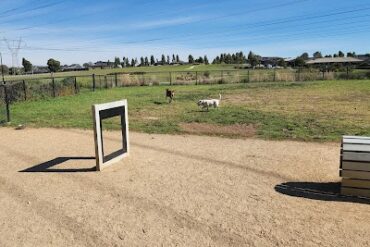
[0,0,370,65]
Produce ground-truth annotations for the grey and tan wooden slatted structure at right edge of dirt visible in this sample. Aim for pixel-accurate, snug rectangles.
[340,136,370,198]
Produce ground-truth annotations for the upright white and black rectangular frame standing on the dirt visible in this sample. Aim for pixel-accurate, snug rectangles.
[92,100,130,171]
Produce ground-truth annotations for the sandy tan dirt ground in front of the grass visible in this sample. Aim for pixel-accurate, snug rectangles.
[0,128,370,246]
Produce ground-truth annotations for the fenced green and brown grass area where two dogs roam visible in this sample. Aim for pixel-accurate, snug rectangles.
[6,80,370,141]
